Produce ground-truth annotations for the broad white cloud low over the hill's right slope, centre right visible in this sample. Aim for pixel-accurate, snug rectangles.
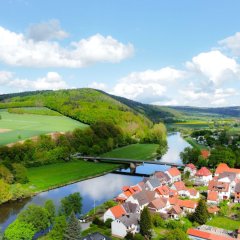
[113,67,185,100]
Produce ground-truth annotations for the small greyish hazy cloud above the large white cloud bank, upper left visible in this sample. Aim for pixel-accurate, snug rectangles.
[27,19,68,41]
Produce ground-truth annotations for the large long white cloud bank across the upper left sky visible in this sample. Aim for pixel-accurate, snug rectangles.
[0,27,134,68]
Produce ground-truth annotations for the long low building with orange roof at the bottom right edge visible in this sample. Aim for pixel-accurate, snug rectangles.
[187,225,236,240]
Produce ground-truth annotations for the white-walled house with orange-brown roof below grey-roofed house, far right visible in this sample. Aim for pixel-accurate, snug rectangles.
[208,180,231,201]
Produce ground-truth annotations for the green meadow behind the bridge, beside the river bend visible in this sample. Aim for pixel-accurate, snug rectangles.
[102,144,159,160]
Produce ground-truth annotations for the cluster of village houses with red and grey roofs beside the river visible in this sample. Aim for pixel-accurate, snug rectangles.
[103,164,240,238]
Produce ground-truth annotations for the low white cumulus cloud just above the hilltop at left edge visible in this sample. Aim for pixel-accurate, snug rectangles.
[0,72,68,91]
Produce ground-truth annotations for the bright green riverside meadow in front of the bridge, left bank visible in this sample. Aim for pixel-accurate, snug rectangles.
[26,160,119,192]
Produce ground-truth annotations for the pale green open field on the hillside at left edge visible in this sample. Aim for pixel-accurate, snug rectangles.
[0,110,86,145]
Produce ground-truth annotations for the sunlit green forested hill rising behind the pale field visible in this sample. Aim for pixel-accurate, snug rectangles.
[0,88,153,135]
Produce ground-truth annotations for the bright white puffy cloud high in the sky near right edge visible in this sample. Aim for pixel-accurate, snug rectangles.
[186,50,240,84]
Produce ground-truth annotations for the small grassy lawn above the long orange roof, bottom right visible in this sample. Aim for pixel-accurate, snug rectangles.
[206,216,240,230]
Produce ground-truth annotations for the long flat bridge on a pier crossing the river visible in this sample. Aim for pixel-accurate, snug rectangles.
[72,153,185,173]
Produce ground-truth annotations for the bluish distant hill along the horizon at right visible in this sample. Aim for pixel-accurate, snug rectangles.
[169,106,240,117]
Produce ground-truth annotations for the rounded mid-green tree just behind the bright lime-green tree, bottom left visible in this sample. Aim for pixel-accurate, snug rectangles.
[18,204,50,232]
